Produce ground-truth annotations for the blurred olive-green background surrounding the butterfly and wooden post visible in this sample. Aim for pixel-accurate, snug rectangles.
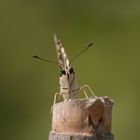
[0,0,140,140]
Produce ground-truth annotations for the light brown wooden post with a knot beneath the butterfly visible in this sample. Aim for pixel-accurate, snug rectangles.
[49,97,114,140]
